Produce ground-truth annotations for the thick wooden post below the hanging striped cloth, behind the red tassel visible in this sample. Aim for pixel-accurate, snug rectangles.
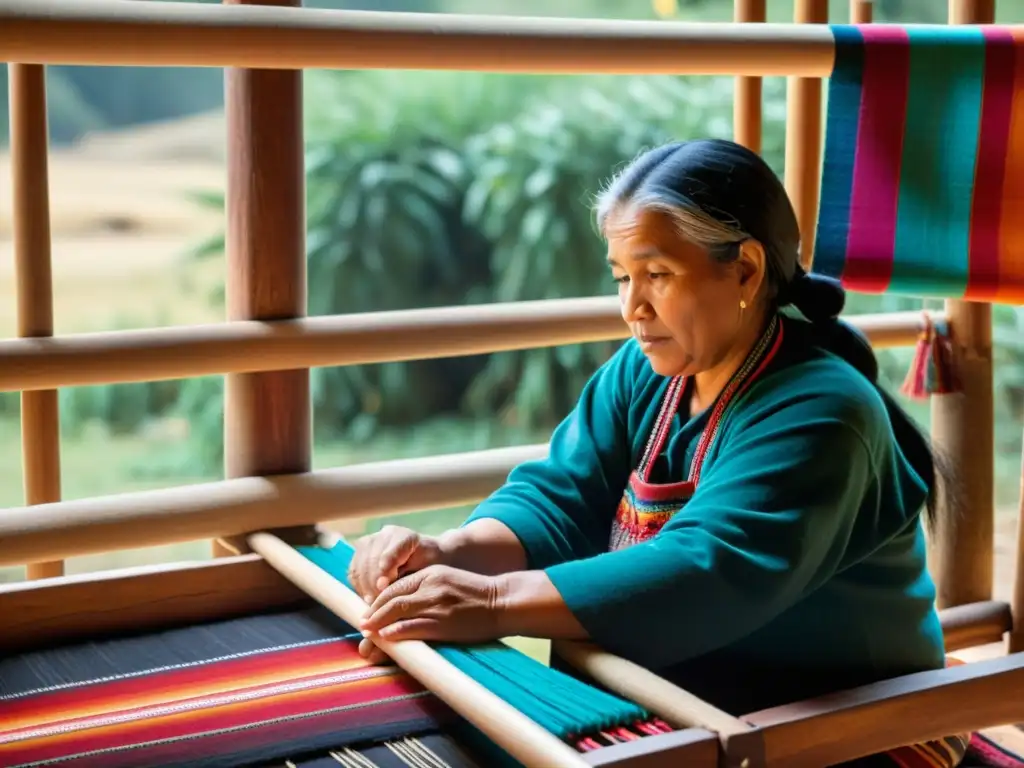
[929,0,995,608]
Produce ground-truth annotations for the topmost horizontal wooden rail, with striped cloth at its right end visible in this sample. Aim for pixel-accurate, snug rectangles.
[0,0,835,77]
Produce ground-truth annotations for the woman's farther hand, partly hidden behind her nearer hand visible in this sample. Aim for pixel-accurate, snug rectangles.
[348,525,443,603]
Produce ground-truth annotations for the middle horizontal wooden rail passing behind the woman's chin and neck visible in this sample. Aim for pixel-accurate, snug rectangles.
[0,297,937,391]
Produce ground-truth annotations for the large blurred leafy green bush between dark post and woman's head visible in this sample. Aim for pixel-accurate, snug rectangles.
[172,72,782,475]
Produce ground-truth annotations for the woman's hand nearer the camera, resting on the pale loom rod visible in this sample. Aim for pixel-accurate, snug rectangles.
[359,565,501,662]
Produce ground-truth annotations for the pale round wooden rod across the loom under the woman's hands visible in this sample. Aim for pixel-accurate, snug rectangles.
[248,534,587,768]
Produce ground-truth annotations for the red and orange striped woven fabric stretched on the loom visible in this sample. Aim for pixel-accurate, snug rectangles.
[0,637,455,768]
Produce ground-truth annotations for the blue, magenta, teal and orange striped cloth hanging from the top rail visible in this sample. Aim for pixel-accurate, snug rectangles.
[814,25,1024,303]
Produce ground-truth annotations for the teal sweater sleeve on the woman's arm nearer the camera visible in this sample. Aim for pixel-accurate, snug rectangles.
[547,376,901,668]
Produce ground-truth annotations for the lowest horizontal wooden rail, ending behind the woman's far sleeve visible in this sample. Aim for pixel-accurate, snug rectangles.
[0,444,548,566]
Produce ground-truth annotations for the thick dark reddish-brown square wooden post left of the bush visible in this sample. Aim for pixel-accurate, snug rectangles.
[214,0,312,555]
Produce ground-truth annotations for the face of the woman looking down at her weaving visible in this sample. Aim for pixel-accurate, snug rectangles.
[605,210,763,376]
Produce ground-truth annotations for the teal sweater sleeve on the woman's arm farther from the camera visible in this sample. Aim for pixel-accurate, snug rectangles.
[467,343,644,569]
